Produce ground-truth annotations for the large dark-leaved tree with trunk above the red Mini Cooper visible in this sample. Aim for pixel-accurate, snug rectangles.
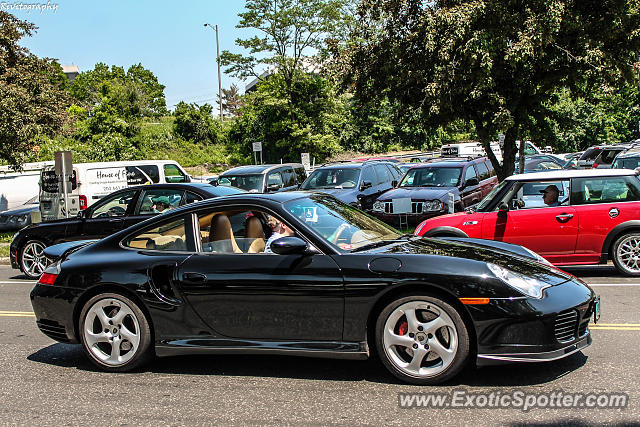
[343,0,640,179]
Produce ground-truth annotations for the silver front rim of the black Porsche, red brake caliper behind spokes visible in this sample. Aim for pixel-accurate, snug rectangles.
[383,301,458,378]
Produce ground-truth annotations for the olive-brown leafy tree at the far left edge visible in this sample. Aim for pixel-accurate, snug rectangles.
[0,11,69,167]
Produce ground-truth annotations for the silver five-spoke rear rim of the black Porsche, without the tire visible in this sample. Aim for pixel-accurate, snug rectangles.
[83,298,140,367]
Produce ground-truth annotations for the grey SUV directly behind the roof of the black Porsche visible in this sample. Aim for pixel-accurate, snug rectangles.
[217,163,307,193]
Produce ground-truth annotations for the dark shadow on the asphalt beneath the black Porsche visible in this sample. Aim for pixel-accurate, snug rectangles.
[27,344,587,387]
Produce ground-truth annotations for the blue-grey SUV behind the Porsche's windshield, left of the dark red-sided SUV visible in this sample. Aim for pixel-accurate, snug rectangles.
[301,160,402,211]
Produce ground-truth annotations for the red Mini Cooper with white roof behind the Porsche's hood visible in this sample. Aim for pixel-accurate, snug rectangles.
[415,169,640,276]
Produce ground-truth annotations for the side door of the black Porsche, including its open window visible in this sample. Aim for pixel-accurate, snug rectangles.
[178,206,344,341]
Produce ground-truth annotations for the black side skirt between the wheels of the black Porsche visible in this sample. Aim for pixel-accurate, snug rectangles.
[155,338,369,360]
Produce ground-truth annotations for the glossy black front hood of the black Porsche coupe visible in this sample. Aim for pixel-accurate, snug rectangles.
[362,238,574,285]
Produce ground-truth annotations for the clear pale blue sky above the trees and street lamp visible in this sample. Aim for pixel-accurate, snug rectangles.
[10,0,252,109]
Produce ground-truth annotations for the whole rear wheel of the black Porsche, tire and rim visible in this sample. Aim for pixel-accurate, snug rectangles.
[78,293,153,372]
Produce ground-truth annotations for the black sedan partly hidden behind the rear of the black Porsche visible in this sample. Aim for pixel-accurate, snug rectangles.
[10,183,244,279]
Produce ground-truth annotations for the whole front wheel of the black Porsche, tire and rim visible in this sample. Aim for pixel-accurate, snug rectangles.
[376,295,469,385]
